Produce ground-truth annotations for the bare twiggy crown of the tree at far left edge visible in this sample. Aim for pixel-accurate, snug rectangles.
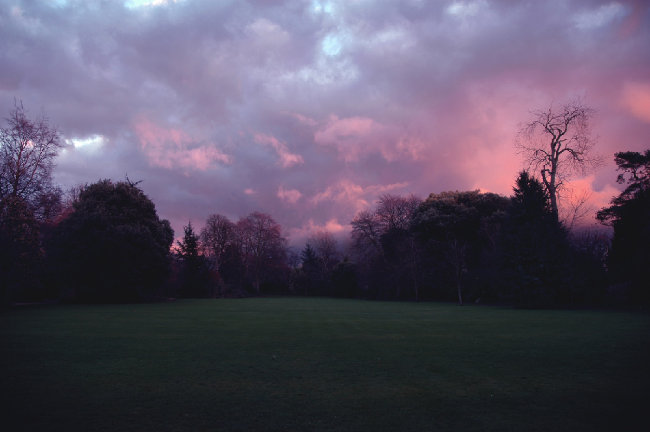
[0,102,62,208]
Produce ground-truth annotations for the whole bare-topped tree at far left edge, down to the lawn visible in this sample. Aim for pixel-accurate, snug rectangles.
[0,102,62,306]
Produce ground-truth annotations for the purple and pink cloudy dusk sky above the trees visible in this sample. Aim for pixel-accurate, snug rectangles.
[0,0,650,245]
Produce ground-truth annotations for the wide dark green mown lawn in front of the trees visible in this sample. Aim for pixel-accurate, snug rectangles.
[0,298,650,431]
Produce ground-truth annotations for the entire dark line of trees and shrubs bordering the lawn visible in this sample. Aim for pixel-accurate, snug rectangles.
[0,102,650,308]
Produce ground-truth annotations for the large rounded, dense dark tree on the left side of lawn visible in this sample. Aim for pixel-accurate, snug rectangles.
[49,180,174,302]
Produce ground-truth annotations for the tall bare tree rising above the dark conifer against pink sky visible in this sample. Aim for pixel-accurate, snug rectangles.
[516,100,601,218]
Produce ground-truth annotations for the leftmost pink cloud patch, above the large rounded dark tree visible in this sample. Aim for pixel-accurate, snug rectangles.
[134,118,232,171]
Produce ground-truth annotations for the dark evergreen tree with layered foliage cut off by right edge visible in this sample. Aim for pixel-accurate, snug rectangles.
[597,149,650,304]
